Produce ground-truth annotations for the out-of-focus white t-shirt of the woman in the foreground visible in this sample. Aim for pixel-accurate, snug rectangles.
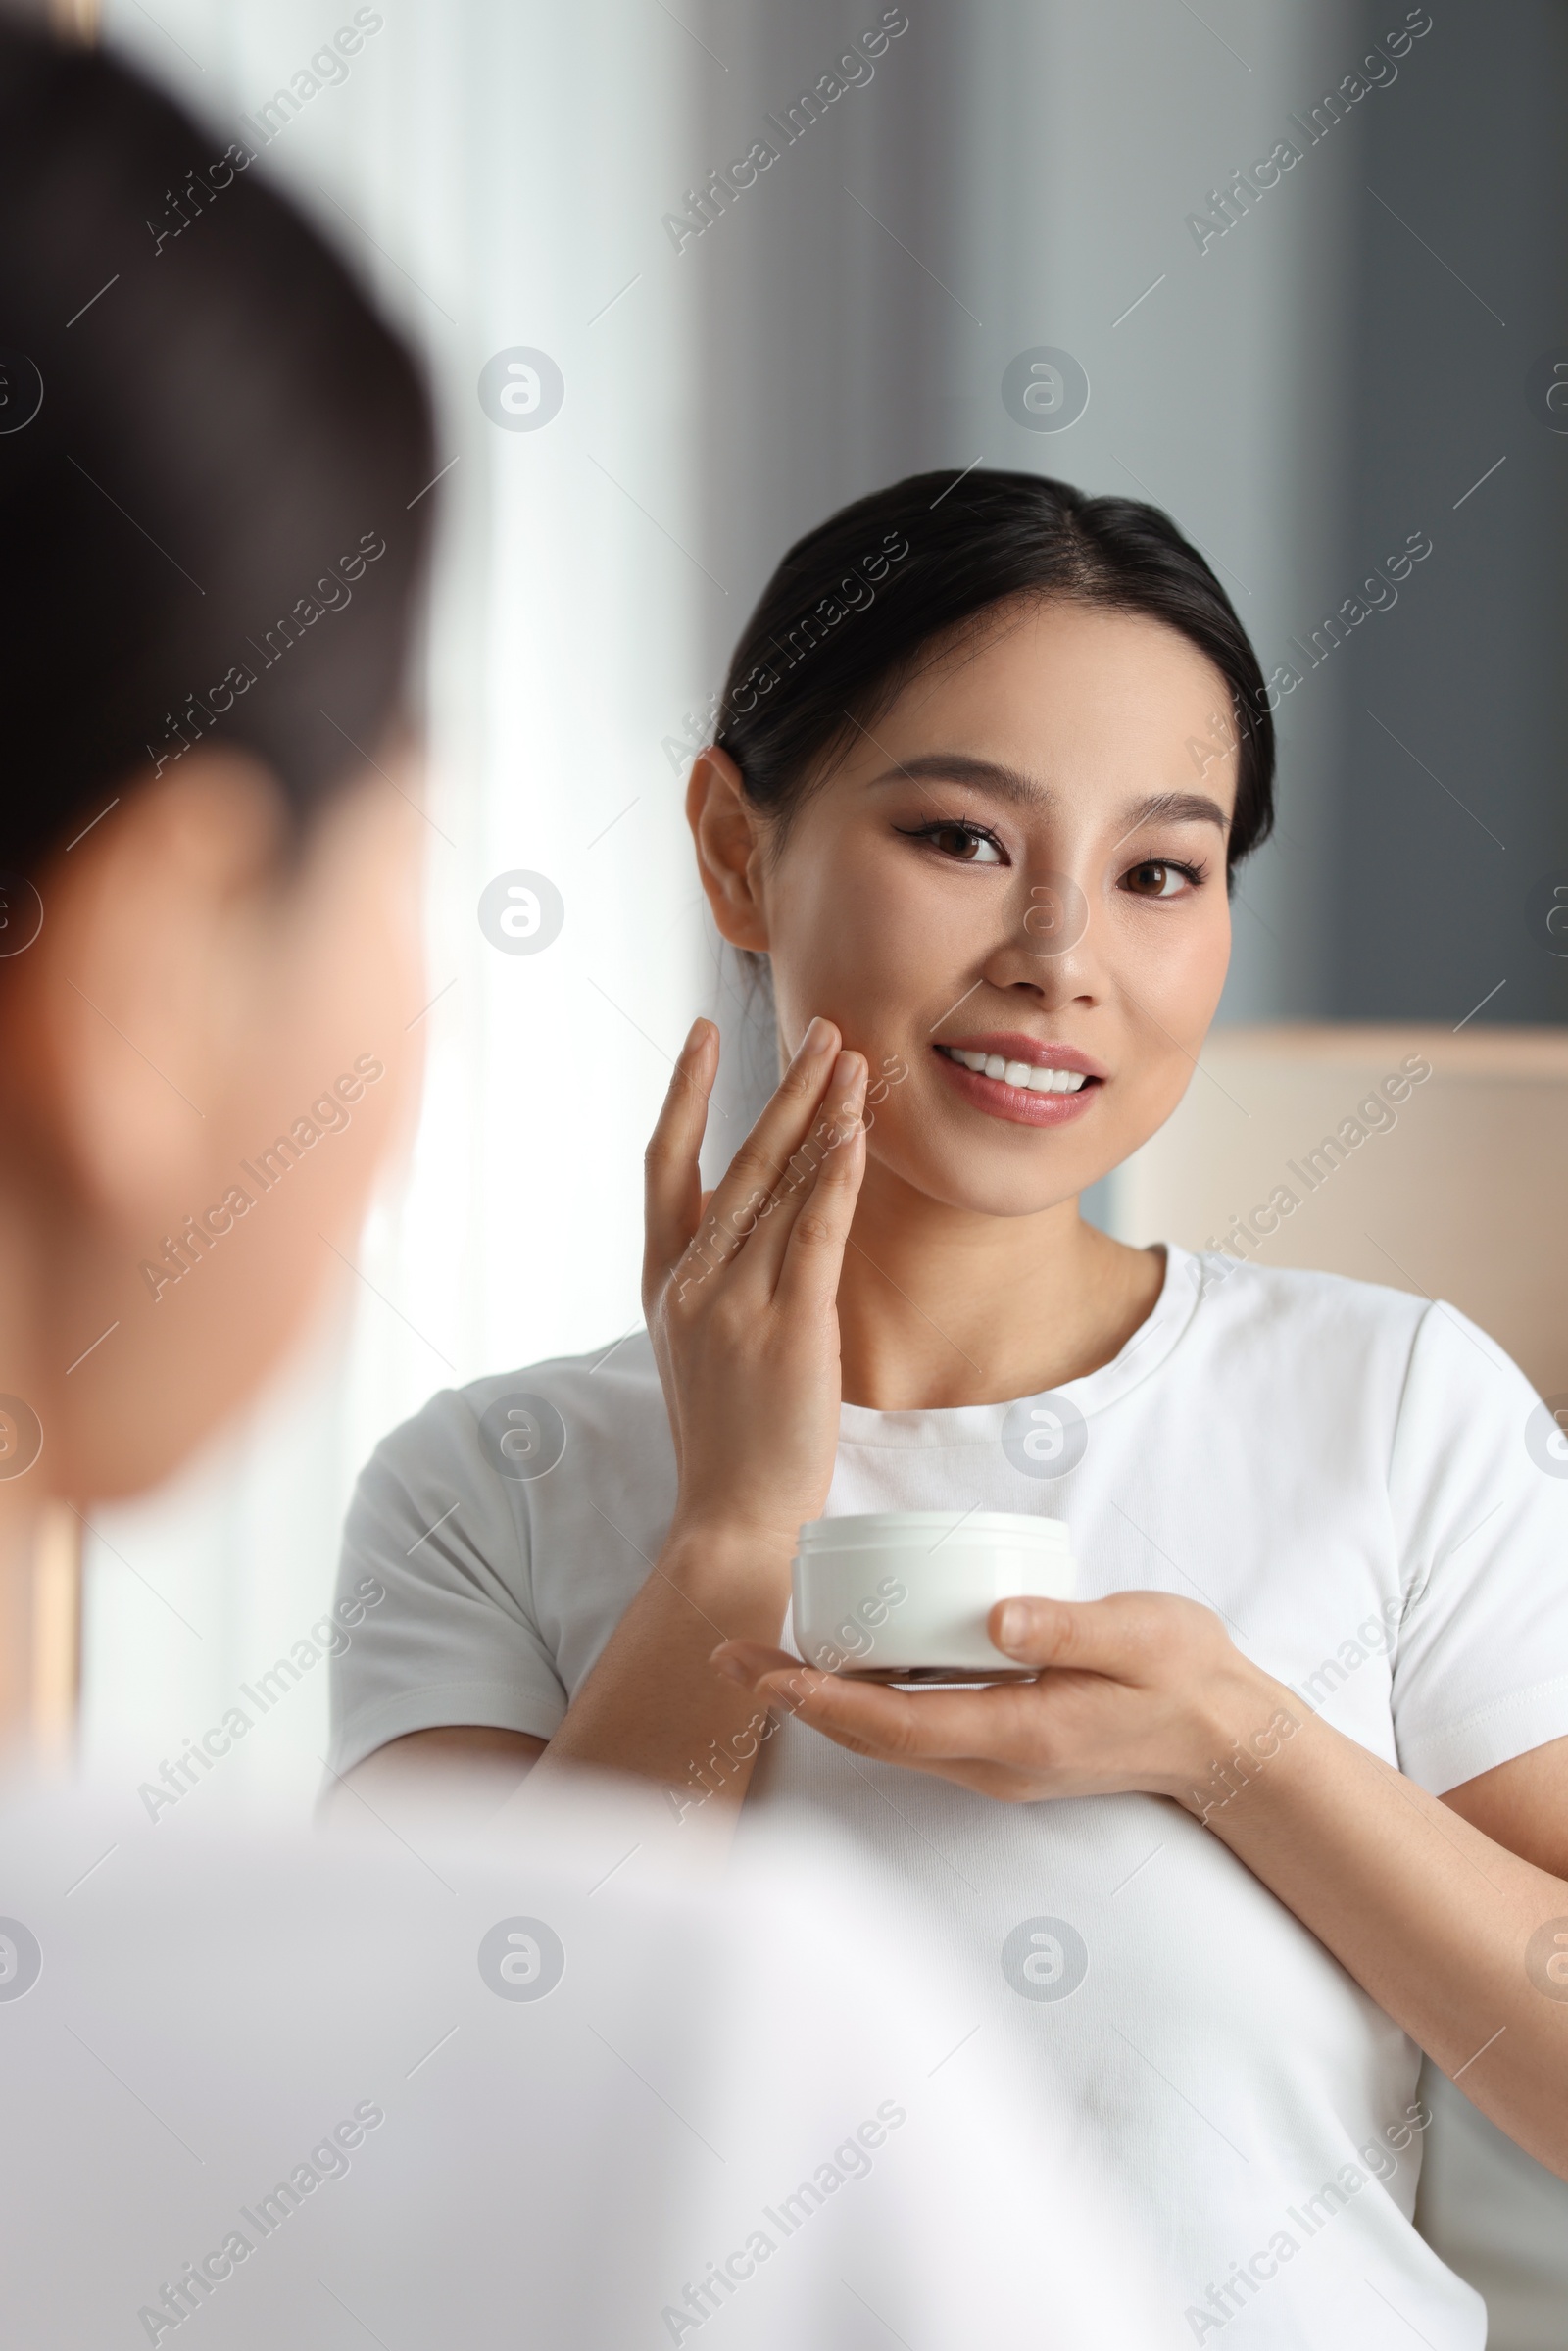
[0,1768,1185,2351]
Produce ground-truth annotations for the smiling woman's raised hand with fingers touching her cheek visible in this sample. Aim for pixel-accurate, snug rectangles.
[642,1020,867,1587]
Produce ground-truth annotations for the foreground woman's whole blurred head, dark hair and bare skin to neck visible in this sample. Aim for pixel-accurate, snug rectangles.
[0,25,435,1559]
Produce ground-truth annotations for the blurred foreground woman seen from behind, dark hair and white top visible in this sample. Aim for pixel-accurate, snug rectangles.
[0,25,1171,2351]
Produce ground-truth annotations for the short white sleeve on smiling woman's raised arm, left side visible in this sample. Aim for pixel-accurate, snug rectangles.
[329,1390,566,1773]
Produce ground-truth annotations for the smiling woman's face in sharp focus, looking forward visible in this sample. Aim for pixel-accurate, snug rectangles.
[753,602,1237,1215]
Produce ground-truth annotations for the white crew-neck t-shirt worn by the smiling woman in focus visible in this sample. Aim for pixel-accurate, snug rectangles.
[334,1249,1568,2351]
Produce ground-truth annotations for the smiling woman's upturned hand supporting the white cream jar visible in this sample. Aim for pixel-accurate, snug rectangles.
[712,1592,1298,1820]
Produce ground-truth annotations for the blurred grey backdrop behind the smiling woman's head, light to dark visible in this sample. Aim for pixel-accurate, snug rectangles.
[682,0,1568,1100]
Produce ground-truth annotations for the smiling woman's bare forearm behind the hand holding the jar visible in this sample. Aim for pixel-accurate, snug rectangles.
[1206,1690,1568,2177]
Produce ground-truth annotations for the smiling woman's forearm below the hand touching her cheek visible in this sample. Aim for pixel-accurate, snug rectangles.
[536,1528,790,1820]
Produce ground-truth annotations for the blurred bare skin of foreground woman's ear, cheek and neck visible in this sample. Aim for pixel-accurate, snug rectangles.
[0,750,425,1500]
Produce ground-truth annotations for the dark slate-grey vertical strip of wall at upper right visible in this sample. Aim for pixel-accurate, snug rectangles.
[1324,0,1568,1025]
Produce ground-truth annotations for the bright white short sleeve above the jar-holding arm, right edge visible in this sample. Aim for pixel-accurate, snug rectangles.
[1390,1302,1568,1796]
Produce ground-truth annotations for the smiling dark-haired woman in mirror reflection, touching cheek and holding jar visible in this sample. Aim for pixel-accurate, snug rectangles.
[336,472,1568,2351]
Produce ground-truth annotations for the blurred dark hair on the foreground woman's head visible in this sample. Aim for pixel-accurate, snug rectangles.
[0,25,435,874]
